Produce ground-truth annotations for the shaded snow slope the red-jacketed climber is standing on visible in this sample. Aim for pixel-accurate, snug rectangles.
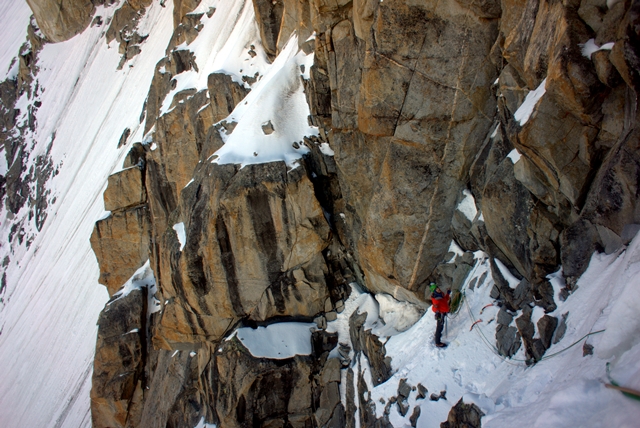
[360,232,640,428]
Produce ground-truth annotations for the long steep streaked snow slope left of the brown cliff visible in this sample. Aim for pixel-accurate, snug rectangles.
[0,0,172,427]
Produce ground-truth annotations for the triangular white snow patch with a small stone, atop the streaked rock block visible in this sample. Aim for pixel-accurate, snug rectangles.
[212,36,318,168]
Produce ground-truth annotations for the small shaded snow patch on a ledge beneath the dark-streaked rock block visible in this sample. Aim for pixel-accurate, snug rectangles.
[235,322,316,360]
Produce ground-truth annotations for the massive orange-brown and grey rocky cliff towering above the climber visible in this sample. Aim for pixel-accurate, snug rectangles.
[36,0,640,427]
